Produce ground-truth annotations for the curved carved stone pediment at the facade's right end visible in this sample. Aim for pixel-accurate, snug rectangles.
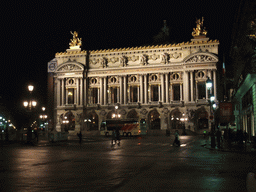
[184,54,218,63]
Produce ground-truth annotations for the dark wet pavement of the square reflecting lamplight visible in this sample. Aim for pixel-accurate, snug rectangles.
[0,136,256,192]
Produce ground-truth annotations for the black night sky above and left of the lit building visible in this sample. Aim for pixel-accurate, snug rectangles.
[0,0,239,127]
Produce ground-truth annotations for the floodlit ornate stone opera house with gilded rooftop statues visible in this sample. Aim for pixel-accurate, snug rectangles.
[48,20,219,134]
